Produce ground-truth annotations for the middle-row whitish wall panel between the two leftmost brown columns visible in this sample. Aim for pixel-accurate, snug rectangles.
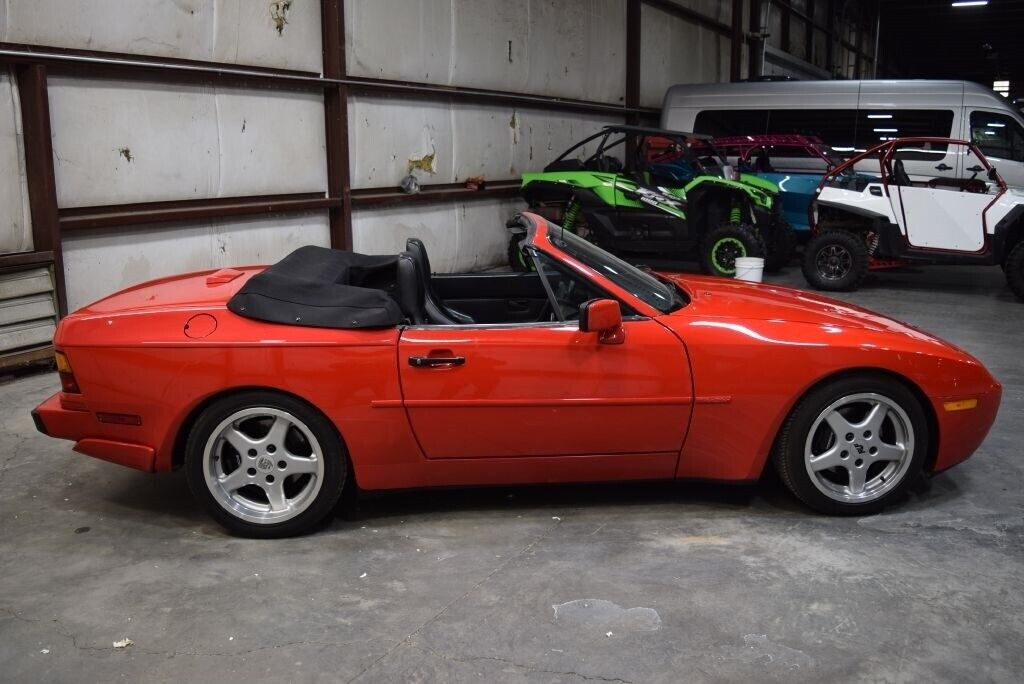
[49,77,327,207]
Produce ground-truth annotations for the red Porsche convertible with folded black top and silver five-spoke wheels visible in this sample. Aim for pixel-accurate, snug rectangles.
[33,214,1001,538]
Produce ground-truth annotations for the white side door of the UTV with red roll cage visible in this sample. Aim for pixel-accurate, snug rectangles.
[889,144,993,252]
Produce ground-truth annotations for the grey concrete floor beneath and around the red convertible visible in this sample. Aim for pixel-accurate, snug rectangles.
[0,267,1024,682]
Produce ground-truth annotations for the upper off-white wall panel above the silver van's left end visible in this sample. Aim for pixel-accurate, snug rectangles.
[640,5,730,108]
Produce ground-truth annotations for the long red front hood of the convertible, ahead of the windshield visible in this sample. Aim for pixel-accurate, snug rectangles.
[662,273,940,341]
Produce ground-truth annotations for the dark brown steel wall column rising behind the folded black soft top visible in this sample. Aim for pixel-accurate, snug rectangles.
[321,0,352,250]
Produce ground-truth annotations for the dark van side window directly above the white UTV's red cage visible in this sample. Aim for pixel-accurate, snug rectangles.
[855,110,953,163]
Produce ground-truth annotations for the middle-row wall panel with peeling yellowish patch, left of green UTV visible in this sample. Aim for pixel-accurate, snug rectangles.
[348,96,622,187]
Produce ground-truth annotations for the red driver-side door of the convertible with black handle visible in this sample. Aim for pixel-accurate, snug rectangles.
[398,318,692,459]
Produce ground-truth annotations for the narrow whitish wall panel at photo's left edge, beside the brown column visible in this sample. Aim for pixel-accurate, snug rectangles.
[0,72,32,254]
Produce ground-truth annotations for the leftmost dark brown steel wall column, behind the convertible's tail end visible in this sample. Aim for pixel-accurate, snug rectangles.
[15,65,68,316]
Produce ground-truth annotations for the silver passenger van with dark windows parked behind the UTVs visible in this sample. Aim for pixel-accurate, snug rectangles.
[662,81,1024,187]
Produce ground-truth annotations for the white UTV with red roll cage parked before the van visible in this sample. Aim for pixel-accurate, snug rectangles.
[803,138,1024,299]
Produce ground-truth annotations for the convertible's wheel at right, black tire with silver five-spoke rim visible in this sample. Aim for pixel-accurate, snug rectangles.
[773,373,929,515]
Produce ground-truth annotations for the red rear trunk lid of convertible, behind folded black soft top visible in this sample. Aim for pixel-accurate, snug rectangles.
[76,266,266,315]
